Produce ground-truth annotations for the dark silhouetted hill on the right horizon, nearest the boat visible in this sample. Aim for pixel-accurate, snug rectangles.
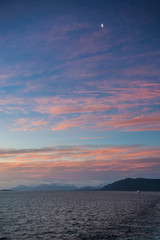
[100,178,160,191]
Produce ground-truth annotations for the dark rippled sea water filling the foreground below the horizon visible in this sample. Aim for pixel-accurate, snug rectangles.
[0,191,160,240]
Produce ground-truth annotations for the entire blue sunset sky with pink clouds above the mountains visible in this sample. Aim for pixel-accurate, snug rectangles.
[0,0,160,189]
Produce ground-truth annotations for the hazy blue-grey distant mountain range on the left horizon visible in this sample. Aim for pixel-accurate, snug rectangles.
[11,183,77,191]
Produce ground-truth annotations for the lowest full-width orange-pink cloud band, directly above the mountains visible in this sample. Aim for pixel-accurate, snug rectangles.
[0,146,160,186]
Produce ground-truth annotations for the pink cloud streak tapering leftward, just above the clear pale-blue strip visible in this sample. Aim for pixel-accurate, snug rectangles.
[48,113,160,131]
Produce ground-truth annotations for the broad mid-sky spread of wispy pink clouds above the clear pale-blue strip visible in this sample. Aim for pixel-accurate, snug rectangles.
[0,80,160,131]
